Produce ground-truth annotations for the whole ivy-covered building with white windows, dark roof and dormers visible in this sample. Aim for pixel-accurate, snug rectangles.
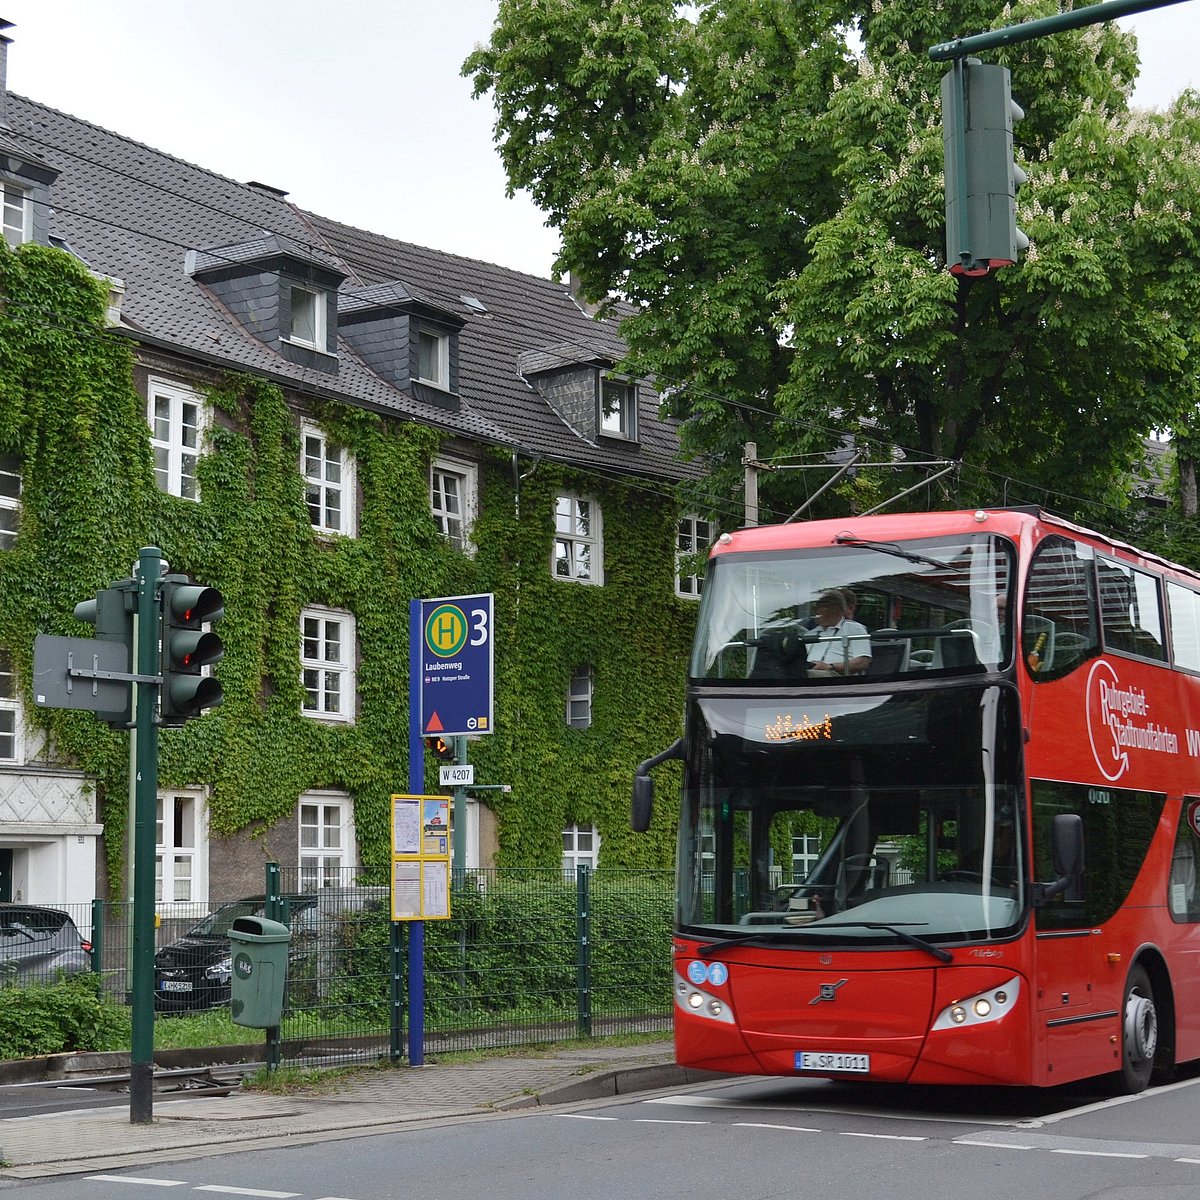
[0,25,712,914]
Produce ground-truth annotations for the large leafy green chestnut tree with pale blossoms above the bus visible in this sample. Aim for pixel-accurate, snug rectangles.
[463,0,1200,525]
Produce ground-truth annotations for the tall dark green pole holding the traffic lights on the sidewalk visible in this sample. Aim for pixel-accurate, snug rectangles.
[130,546,163,1124]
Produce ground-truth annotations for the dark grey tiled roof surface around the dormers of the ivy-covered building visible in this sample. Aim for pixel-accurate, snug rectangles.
[7,94,700,480]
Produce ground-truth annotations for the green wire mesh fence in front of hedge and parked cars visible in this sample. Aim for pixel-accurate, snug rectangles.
[21,864,673,1063]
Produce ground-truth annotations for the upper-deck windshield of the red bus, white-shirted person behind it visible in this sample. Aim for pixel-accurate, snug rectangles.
[691,533,1015,684]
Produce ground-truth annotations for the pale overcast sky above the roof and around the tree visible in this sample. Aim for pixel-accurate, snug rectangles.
[0,0,1200,275]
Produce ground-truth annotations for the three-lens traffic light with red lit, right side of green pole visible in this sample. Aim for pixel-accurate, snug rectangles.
[158,575,224,726]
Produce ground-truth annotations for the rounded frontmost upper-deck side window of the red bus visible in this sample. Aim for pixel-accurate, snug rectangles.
[1021,536,1099,682]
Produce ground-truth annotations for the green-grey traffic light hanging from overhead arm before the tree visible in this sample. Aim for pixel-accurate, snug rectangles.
[942,58,1030,275]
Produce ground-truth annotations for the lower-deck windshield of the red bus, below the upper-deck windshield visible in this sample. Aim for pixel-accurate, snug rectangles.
[677,684,1027,954]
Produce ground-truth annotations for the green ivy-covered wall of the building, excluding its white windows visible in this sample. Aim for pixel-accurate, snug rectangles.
[0,129,696,901]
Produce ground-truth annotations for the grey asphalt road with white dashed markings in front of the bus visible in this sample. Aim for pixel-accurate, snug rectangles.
[14,1078,1200,1200]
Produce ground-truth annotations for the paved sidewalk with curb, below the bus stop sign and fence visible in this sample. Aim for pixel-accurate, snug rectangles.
[0,1042,712,1183]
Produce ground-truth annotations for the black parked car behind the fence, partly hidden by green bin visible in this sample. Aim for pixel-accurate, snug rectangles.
[154,894,317,1013]
